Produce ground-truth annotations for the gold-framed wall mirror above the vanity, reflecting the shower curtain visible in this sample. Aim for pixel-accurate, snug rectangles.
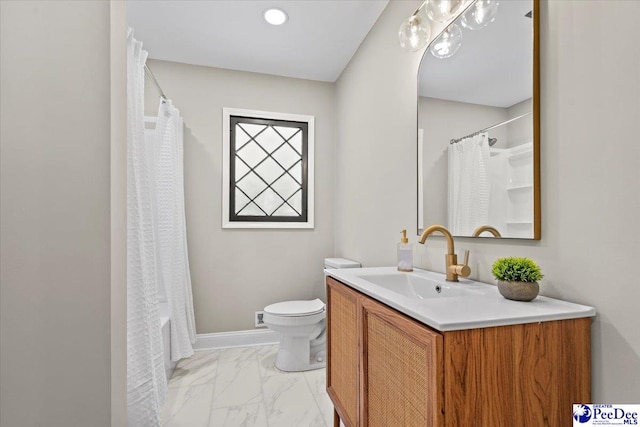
[417,0,541,240]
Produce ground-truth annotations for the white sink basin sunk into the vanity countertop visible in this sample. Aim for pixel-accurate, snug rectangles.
[358,273,482,299]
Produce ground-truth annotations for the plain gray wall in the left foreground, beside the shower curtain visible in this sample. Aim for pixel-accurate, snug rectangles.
[0,1,124,427]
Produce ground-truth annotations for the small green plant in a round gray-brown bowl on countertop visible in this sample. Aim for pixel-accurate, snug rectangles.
[491,257,543,301]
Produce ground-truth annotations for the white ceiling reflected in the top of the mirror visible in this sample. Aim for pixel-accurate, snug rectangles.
[419,0,533,108]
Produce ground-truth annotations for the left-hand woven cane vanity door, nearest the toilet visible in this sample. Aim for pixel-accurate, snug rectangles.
[327,277,362,427]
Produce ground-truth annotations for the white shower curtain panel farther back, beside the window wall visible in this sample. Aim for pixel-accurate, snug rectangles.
[152,100,196,361]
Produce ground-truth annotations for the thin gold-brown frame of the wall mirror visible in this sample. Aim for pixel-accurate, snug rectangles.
[415,0,542,240]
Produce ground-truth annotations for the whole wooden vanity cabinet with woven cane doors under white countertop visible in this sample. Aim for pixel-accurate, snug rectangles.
[327,277,591,427]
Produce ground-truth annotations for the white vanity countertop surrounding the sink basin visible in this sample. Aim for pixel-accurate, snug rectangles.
[324,267,596,331]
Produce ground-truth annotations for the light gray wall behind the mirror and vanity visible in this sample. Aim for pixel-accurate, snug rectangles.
[336,1,640,403]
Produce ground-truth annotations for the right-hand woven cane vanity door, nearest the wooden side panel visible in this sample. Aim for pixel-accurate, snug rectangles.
[361,298,444,427]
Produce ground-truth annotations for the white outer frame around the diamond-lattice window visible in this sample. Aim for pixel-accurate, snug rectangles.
[222,107,315,229]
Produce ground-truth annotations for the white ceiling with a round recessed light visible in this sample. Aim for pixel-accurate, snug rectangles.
[127,0,384,82]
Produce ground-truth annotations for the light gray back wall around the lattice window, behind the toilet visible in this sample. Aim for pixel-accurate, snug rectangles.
[143,61,335,334]
